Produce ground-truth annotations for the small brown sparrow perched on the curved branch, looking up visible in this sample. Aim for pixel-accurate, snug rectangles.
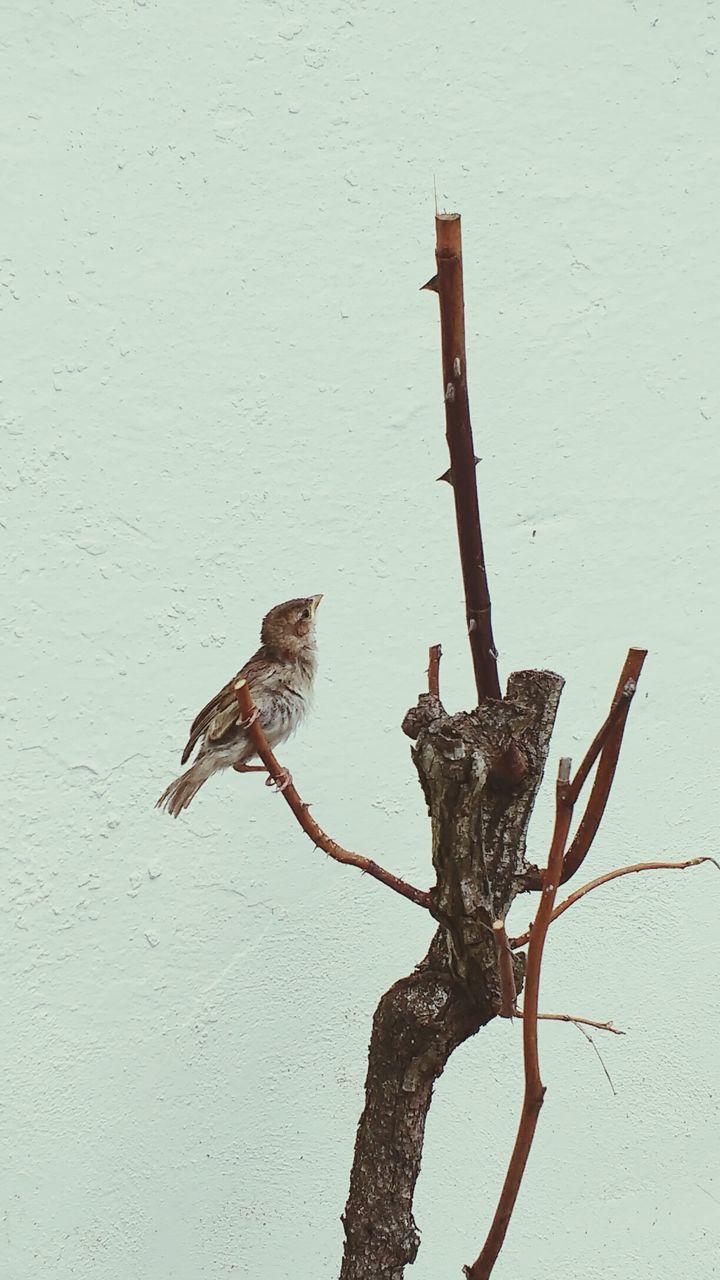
[156,595,323,818]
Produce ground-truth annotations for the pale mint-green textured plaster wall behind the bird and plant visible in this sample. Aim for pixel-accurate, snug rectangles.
[0,0,720,1280]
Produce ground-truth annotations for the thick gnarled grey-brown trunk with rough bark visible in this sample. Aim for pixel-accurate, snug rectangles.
[341,671,562,1280]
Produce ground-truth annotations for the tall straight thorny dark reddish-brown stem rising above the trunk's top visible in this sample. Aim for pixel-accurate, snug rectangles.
[424,214,502,703]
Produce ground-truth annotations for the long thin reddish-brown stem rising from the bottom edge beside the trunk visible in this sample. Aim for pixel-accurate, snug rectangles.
[465,759,573,1280]
